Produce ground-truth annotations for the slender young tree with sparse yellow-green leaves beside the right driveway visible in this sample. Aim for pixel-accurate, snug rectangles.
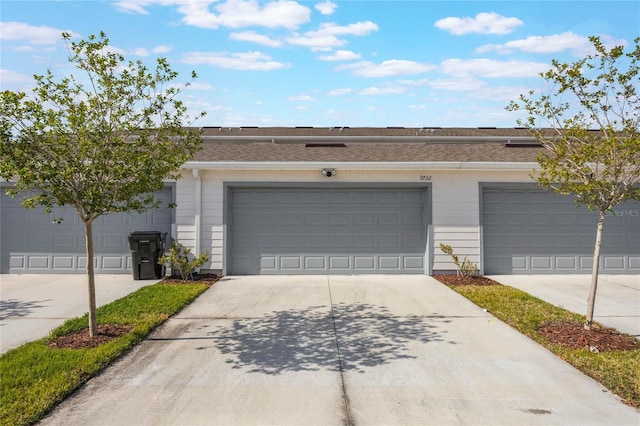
[507,37,640,329]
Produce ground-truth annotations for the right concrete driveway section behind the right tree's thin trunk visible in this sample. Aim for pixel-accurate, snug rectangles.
[489,274,640,338]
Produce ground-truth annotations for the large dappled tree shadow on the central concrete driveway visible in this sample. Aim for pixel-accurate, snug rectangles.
[208,303,449,375]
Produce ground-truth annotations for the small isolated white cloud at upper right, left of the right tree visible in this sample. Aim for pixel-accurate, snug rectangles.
[435,12,524,35]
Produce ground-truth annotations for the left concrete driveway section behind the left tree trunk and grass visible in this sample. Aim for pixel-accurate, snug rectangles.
[0,274,158,353]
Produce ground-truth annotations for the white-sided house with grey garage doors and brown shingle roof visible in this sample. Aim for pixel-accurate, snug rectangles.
[0,127,640,275]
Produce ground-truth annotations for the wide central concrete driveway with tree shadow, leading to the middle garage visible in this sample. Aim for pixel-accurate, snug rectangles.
[43,276,640,426]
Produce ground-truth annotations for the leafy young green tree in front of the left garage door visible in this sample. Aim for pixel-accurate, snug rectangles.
[0,33,204,337]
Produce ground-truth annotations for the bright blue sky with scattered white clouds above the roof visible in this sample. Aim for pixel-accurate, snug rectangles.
[0,0,640,127]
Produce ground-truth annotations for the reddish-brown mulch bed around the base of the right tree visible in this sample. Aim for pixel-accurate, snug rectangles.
[538,322,640,352]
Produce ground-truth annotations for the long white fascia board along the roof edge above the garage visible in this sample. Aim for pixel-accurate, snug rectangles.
[183,161,540,170]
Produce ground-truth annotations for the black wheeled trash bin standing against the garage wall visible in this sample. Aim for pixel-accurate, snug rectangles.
[129,231,167,280]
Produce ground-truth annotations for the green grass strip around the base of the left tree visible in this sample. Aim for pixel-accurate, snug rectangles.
[0,284,209,426]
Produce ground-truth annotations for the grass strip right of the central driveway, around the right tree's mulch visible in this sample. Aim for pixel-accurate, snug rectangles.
[451,285,640,408]
